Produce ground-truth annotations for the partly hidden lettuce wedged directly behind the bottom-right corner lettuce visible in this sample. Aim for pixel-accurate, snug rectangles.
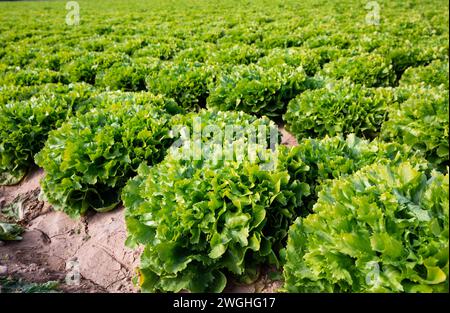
[286,134,427,213]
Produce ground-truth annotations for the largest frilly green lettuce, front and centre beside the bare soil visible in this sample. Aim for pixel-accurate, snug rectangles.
[122,111,309,292]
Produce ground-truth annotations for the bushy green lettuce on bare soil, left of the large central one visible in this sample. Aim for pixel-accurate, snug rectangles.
[35,94,180,216]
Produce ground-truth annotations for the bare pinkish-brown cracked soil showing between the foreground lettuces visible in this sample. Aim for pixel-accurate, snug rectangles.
[0,128,297,292]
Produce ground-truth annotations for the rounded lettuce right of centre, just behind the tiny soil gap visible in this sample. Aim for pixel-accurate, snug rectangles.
[283,82,395,139]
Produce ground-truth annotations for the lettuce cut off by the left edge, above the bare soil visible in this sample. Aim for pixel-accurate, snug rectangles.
[0,84,93,185]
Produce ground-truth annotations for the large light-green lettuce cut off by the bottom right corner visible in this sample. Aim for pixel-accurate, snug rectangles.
[284,162,449,292]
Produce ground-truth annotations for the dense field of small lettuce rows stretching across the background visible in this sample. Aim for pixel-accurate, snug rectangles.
[0,1,449,118]
